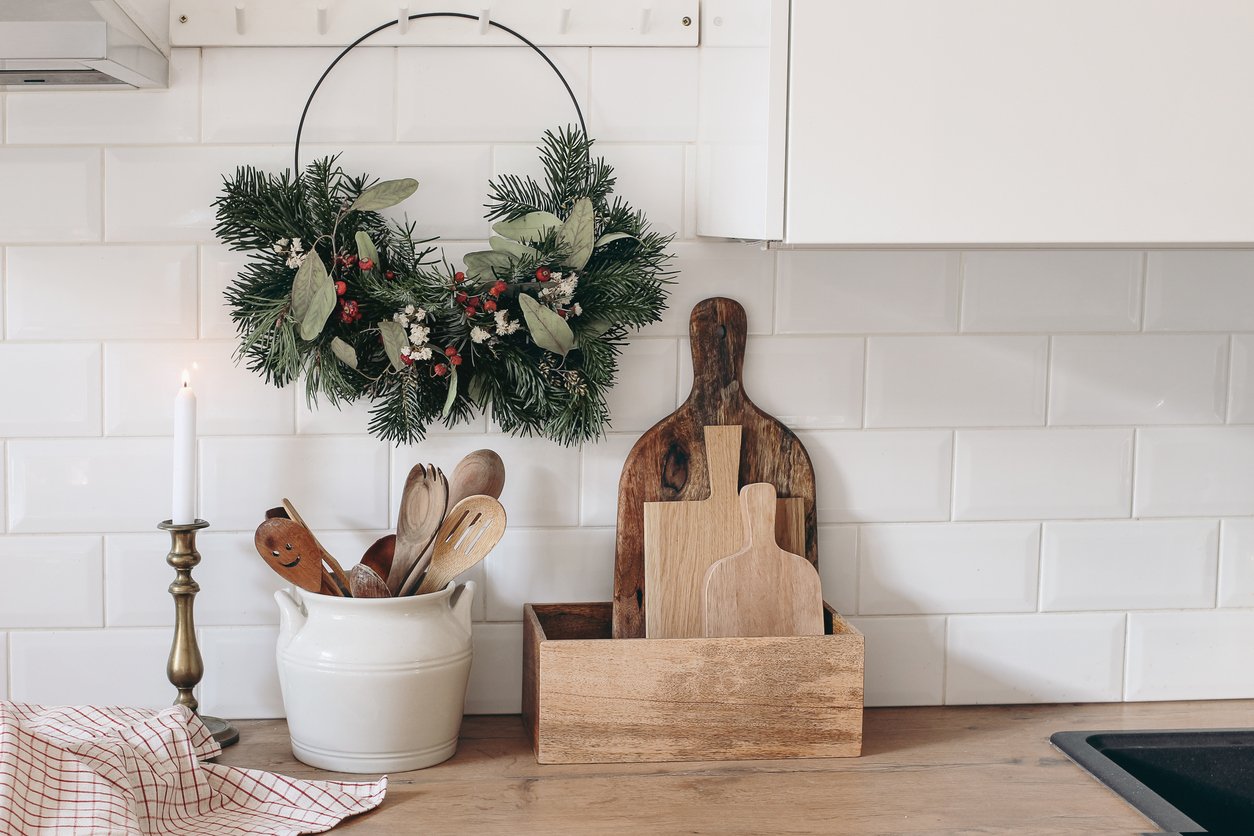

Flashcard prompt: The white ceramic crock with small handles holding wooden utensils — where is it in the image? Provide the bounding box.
[275,582,475,772]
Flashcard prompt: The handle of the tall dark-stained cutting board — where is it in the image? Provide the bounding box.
[688,296,749,405]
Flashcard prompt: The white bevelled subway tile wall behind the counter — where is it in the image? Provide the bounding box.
[0,48,1254,718]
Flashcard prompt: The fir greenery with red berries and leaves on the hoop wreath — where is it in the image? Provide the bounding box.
[214,128,672,445]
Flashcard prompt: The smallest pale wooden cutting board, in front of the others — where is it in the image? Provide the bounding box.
[702,483,823,637]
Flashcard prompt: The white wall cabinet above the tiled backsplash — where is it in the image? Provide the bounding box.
[697,0,1254,246]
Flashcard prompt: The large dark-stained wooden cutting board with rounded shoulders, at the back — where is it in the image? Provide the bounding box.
[613,297,819,638]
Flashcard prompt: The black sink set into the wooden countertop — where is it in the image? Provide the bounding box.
[1050,728,1254,833]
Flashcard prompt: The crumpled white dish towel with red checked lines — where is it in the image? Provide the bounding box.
[0,702,387,836]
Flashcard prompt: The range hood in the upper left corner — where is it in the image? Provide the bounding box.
[0,0,169,91]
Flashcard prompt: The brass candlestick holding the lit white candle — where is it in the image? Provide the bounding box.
[157,520,240,747]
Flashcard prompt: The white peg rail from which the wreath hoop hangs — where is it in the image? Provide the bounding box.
[169,0,700,46]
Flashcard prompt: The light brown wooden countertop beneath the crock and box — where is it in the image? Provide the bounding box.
[219,701,1254,836]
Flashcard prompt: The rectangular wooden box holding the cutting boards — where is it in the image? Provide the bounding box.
[523,602,864,763]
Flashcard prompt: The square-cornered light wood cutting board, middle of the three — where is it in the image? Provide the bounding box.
[645,426,805,638]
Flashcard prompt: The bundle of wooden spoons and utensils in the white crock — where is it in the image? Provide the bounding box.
[255,450,505,598]
